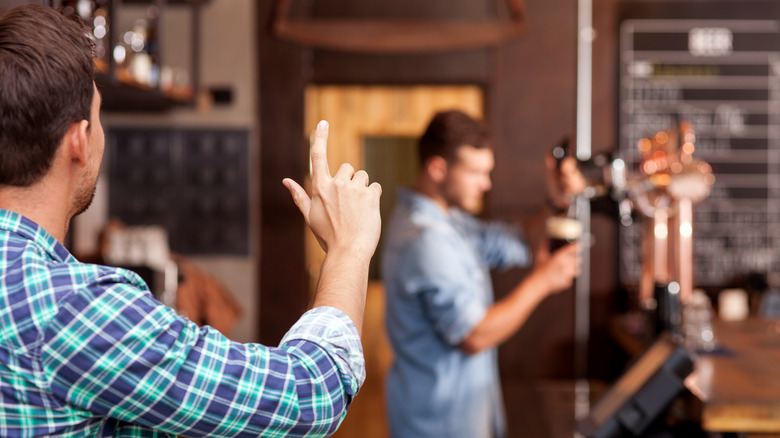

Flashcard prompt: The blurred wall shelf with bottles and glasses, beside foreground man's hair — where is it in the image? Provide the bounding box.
[53,0,201,111]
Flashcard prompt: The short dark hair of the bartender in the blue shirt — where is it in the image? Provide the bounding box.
[418,110,490,164]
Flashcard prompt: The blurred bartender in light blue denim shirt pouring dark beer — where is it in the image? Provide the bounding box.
[382,111,585,438]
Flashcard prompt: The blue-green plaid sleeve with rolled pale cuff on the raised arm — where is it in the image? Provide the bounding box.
[40,278,364,437]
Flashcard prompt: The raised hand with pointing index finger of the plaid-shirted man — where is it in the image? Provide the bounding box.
[283,120,382,258]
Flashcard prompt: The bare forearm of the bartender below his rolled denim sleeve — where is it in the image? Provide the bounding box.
[460,272,549,354]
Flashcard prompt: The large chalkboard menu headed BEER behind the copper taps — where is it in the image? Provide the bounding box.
[619,1,780,287]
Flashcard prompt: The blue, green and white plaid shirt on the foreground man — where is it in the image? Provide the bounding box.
[0,210,365,437]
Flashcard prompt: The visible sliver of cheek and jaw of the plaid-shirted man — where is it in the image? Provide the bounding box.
[71,85,106,217]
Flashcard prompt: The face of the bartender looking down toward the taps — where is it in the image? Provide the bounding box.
[442,145,495,213]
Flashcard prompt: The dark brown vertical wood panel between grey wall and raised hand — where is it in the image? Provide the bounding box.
[256,2,308,345]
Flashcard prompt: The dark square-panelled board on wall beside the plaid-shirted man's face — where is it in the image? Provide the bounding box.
[107,127,249,255]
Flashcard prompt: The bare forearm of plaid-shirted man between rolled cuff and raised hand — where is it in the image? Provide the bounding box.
[313,248,371,334]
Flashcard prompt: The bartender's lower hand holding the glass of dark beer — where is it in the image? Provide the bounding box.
[530,243,581,293]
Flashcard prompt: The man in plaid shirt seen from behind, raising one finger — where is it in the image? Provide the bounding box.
[0,6,381,437]
